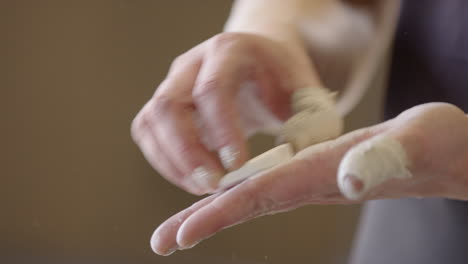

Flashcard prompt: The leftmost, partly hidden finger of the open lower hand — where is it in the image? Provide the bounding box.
[151,194,218,256]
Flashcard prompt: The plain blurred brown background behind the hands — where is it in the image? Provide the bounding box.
[0,0,381,264]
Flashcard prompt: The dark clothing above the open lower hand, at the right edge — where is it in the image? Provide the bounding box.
[386,0,468,118]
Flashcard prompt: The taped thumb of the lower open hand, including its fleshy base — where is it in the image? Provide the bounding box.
[338,103,466,199]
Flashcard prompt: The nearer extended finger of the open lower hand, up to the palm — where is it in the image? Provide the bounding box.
[177,158,322,248]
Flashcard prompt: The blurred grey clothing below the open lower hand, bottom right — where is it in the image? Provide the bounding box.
[352,199,468,264]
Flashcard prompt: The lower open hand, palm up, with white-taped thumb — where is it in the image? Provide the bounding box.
[151,103,468,255]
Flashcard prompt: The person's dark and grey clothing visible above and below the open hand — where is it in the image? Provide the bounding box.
[352,0,468,264]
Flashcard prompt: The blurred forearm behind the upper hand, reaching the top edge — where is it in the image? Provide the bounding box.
[225,0,384,114]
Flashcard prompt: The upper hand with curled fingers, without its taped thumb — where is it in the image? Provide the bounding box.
[132,33,318,194]
